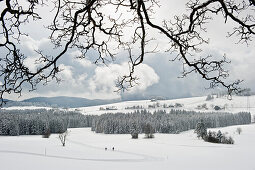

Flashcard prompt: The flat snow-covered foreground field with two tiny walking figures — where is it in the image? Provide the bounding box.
[0,124,255,170]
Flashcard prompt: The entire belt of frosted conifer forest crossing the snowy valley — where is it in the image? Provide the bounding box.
[0,109,251,136]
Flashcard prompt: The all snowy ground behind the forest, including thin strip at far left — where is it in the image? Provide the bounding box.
[4,95,255,119]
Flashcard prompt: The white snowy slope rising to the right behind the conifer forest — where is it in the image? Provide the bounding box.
[70,96,255,115]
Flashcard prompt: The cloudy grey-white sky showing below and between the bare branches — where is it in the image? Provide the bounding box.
[0,0,255,100]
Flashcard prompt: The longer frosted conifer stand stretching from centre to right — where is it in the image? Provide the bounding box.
[92,110,251,134]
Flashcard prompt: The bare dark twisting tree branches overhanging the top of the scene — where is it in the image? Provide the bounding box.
[0,0,255,103]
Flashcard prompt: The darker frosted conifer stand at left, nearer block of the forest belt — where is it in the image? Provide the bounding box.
[0,109,92,136]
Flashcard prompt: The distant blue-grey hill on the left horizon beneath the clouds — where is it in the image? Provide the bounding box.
[4,96,120,108]
